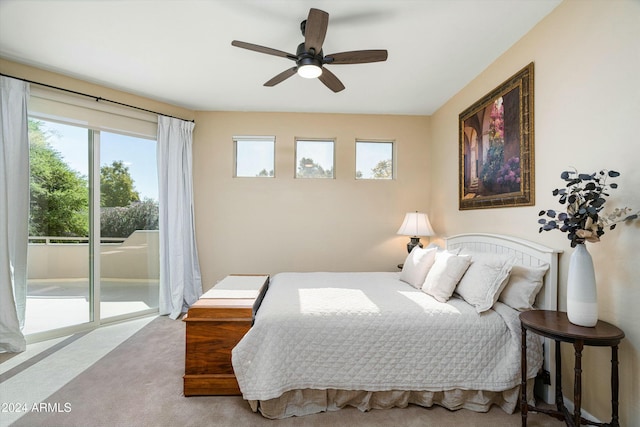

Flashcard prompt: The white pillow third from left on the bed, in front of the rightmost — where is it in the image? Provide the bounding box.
[455,252,516,313]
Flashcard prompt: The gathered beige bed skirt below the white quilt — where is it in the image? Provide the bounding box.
[249,379,535,419]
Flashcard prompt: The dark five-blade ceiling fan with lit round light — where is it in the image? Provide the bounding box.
[231,8,387,92]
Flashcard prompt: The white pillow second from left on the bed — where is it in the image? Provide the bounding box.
[422,250,471,302]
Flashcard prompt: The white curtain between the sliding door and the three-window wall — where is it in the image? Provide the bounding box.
[158,116,202,319]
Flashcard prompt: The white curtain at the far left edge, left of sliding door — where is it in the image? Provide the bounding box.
[0,76,29,353]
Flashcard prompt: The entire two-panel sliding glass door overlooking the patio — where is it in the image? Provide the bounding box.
[24,118,159,335]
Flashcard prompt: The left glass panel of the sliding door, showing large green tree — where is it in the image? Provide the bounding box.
[23,120,92,335]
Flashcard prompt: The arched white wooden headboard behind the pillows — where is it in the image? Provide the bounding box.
[444,233,562,403]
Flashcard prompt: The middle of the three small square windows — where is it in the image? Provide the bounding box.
[296,139,334,178]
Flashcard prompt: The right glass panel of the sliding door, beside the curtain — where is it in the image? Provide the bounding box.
[100,132,160,319]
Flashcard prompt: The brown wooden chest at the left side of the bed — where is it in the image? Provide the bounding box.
[183,275,269,396]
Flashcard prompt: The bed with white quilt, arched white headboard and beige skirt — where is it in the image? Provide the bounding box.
[232,234,558,419]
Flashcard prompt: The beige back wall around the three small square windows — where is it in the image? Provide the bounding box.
[193,111,429,290]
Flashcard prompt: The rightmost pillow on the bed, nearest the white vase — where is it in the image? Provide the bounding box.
[498,264,549,311]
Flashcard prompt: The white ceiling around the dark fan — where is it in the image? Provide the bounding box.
[0,0,561,115]
